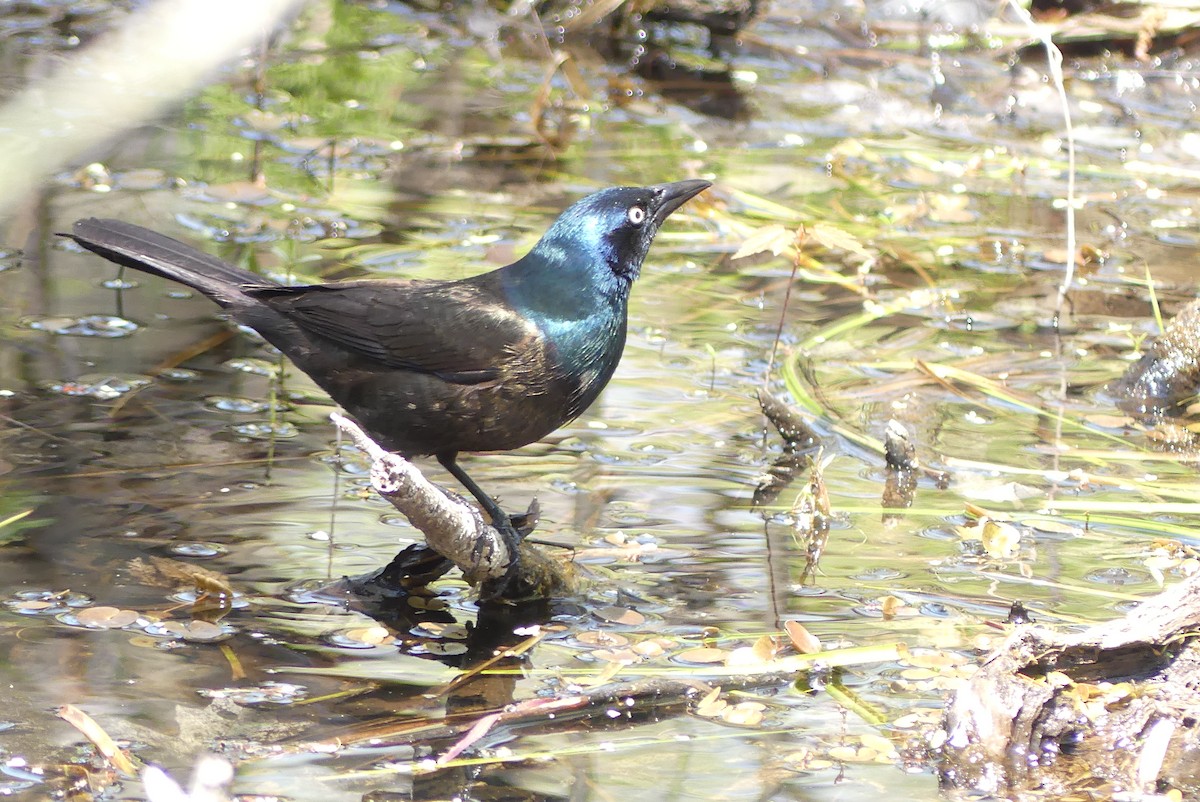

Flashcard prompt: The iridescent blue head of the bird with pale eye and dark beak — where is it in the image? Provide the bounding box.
[526,179,712,291]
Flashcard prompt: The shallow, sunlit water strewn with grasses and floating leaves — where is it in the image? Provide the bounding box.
[0,2,1196,802]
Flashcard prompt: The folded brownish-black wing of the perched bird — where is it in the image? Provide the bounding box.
[253,282,541,384]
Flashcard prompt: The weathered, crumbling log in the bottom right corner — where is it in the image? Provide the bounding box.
[936,576,1200,800]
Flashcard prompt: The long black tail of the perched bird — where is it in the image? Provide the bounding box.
[65,217,271,306]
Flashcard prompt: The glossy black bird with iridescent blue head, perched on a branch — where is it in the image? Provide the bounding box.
[67,180,710,583]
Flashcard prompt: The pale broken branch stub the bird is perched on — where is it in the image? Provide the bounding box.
[330,412,571,595]
